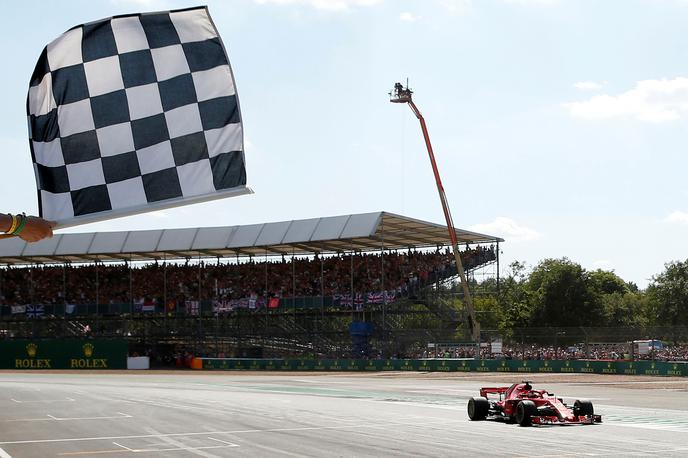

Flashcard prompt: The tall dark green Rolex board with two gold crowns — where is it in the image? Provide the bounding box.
[0,339,129,370]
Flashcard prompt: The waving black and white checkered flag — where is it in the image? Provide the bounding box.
[27,7,246,222]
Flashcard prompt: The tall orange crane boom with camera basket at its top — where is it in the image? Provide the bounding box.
[390,83,480,342]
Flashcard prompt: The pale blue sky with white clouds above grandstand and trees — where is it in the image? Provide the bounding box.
[0,0,688,287]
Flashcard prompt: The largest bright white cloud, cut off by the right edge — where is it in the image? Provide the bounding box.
[563,77,688,123]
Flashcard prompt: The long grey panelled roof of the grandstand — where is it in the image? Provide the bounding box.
[0,212,503,264]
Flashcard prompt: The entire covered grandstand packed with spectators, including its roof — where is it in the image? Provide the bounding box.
[0,212,503,362]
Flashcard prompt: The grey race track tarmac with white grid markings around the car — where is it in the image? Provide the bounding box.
[0,371,688,458]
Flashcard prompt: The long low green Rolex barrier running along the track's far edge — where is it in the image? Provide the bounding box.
[192,358,688,376]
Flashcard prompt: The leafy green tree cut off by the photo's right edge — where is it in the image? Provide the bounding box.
[647,259,688,326]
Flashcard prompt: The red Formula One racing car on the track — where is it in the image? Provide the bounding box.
[468,381,602,426]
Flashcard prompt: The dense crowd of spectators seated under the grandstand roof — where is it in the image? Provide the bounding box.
[0,246,496,305]
